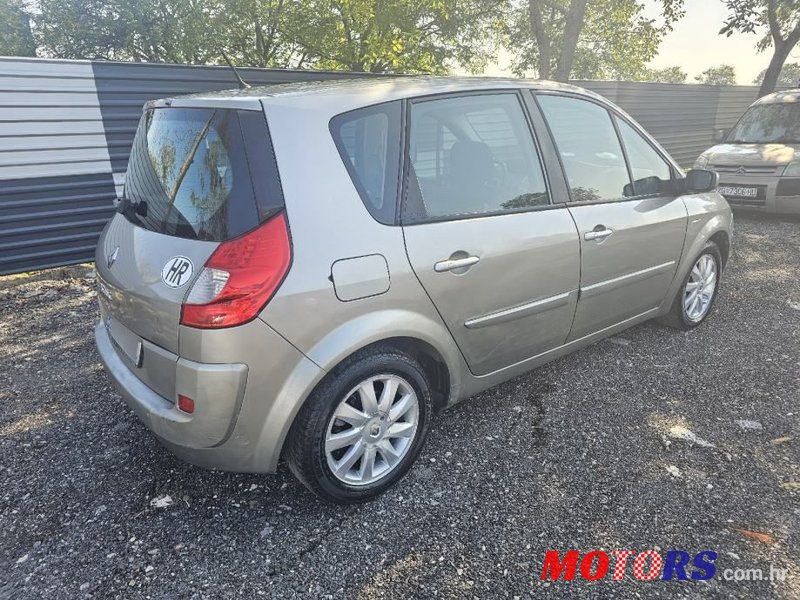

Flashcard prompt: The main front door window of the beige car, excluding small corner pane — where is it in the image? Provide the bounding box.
[537,95,630,202]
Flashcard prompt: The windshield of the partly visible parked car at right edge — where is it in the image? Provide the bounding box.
[726,103,800,144]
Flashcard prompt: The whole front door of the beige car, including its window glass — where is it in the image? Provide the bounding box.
[537,94,687,341]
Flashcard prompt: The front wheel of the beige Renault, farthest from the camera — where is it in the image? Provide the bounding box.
[662,242,722,331]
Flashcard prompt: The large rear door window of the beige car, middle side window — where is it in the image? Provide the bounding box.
[404,93,550,223]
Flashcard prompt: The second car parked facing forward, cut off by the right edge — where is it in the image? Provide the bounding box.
[694,90,800,214]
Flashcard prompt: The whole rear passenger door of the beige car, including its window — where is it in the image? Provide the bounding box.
[402,91,580,375]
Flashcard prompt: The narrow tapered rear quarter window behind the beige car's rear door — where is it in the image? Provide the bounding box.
[330,102,400,225]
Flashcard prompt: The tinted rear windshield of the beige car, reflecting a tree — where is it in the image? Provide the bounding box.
[120,108,283,241]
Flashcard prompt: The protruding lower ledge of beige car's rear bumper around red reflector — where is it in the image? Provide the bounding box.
[95,321,247,450]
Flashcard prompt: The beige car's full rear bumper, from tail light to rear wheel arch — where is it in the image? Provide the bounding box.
[95,319,325,473]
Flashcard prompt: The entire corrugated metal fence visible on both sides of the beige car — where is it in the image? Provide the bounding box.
[0,58,757,274]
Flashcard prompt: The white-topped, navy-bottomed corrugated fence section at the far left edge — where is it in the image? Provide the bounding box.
[0,58,114,274]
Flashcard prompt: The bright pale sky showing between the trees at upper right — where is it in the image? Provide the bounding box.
[485,0,800,85]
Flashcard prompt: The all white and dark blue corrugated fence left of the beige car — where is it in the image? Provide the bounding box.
[0,58,368,274]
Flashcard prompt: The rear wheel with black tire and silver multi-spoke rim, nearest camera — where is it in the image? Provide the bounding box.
[284,347,433,504]
